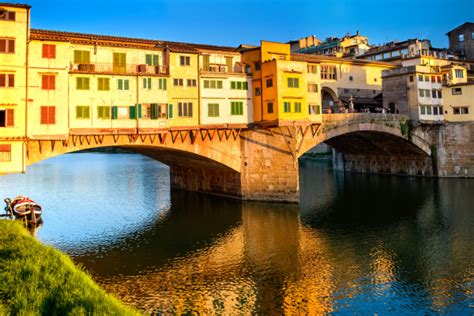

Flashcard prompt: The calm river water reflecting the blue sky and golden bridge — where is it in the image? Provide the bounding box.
[0,153,474,315]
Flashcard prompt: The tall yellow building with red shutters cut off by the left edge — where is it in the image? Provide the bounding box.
[0,3,31,174]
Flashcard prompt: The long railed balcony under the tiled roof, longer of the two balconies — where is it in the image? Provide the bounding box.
[69,63,169,76]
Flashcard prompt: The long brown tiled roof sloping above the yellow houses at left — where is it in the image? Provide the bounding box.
[30,29,238,53]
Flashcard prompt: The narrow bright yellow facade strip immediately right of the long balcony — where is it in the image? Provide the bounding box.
[168,52,200,126]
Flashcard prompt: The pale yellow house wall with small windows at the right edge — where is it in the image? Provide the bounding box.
[443,84,474,122]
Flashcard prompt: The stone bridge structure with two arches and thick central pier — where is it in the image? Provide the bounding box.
[27,114,432,202]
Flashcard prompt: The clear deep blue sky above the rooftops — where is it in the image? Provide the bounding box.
[15,0,474,47]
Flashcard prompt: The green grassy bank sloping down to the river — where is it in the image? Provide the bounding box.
[0,220,138,315]
